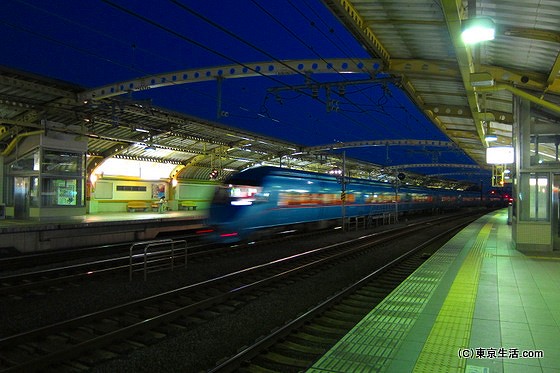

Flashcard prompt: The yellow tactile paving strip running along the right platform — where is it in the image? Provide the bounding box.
[414,223,493,372]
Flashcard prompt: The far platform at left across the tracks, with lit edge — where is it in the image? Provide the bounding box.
[0,210,206,254]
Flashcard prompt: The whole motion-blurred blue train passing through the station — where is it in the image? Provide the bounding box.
[207,166,508,243]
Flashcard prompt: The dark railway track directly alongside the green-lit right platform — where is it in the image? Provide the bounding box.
[208,222,460,373]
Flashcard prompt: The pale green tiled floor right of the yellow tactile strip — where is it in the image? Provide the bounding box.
[468,215,560,373]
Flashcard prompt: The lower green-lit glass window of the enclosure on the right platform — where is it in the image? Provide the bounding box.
[519,173,550,221]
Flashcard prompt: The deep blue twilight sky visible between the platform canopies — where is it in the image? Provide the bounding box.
[0,0,488,182]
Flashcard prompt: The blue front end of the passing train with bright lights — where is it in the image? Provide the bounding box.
[206,179,268,243]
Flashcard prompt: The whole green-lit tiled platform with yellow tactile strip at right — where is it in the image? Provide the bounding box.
[307,210,560,373]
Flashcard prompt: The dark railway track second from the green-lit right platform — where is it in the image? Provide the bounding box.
[0,211,476,371]
